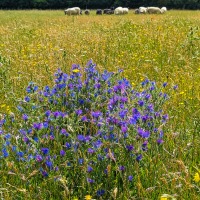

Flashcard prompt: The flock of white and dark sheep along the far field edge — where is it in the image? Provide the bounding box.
[64,7,167,15]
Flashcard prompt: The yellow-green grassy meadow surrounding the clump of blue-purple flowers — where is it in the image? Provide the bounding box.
[0,10,200,200]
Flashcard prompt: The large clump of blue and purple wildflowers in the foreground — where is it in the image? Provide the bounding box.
[0,61,171,199]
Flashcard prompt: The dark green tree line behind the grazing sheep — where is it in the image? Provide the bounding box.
[0,0,200,9]
